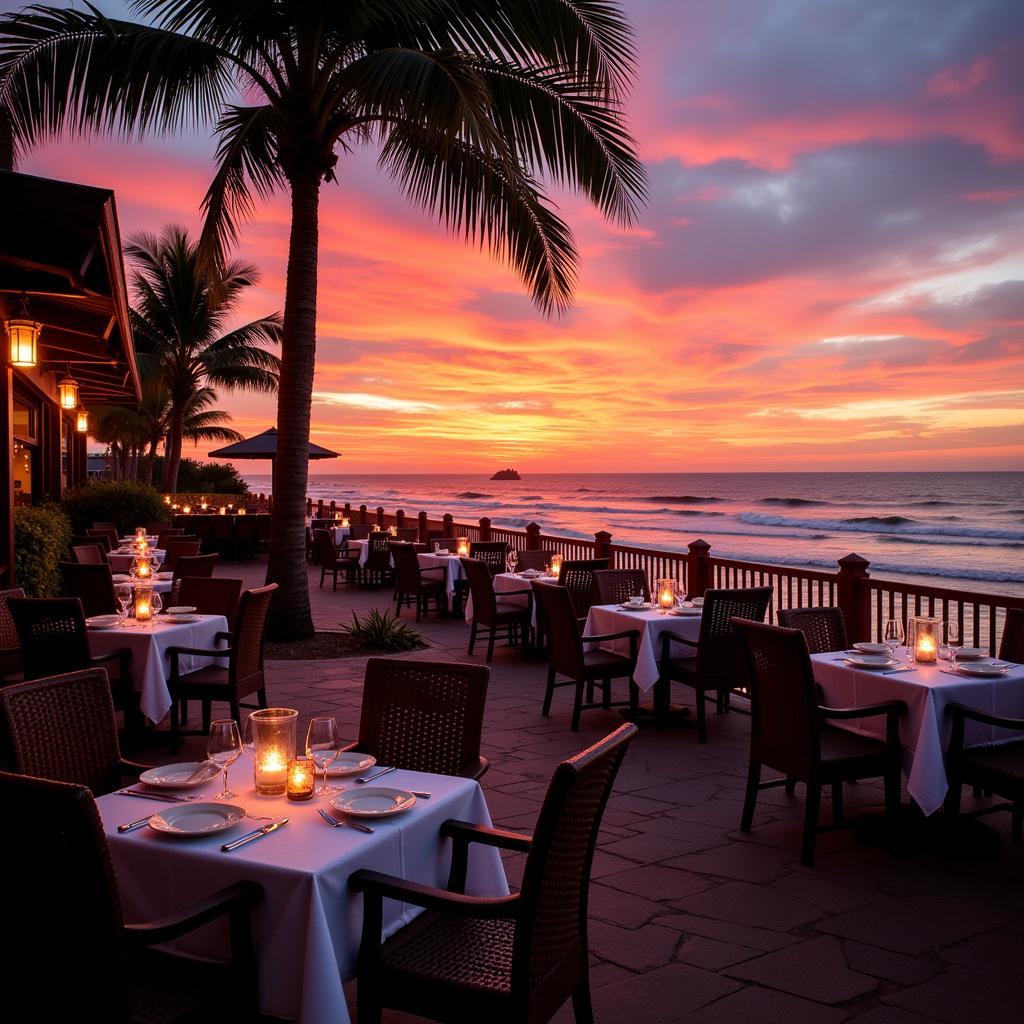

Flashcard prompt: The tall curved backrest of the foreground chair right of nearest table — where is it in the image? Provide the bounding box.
[512,724,637,1003]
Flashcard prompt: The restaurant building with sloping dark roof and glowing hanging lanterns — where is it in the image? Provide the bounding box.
[0,171,140,588]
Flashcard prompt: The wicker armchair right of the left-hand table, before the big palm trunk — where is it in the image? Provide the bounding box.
[167,583,278,748]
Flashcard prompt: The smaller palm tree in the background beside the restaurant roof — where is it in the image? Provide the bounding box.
[125,224,281,494]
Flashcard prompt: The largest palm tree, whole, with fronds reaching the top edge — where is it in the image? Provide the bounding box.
[0,0,644,637]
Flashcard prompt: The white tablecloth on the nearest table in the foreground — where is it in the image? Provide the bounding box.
[97,770,508,1024]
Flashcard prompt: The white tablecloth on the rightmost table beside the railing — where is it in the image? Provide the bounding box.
[811,650,1024,814]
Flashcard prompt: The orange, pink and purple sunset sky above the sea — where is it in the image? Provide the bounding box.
[9,0,1024,472]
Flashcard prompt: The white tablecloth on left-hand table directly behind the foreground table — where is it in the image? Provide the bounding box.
[89,615,227,723]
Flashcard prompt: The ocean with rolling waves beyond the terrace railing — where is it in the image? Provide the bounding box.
[246,466,1024,596]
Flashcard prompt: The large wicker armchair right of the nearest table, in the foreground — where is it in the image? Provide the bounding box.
[349,725,637,1024]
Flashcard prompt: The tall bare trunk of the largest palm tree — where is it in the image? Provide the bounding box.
[266,171,321,640]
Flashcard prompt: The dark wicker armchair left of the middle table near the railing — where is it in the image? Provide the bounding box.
[531,580,640,732]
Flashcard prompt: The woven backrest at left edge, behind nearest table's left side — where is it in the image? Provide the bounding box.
[0,669,121,796]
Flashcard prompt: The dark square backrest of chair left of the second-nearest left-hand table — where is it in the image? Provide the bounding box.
[8,597,90,679]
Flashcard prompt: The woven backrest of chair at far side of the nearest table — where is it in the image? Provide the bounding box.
[358,657,490,775]
